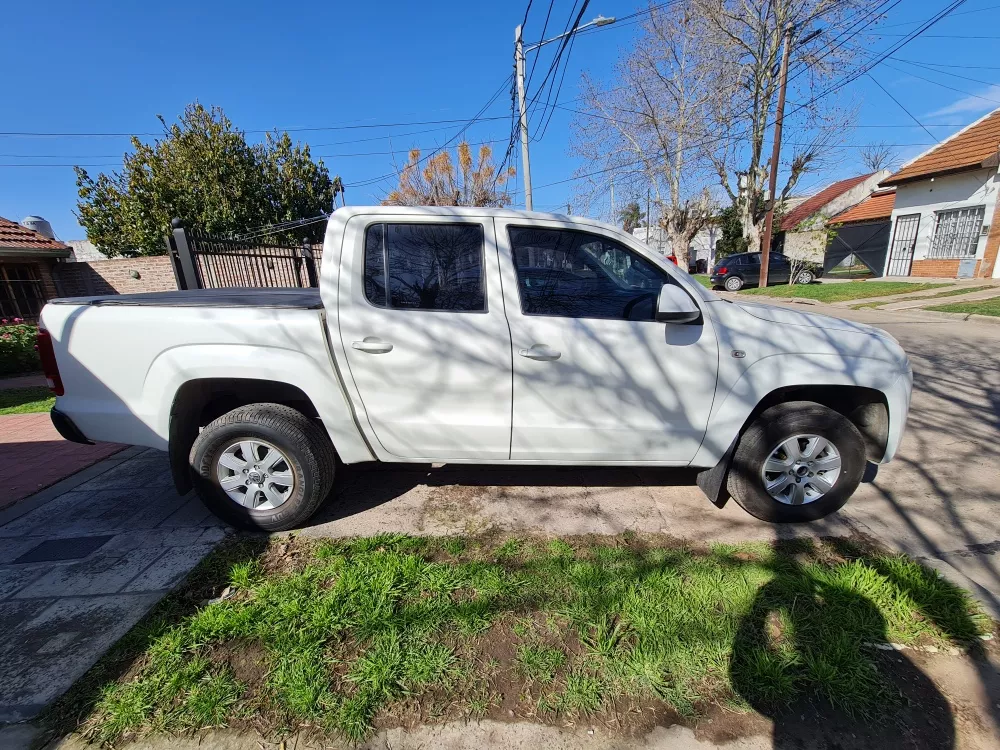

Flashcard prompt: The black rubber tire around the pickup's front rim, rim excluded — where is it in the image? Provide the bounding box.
[727,401,865,523]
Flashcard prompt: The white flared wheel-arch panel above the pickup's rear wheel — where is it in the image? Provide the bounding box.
[142,344,373,463]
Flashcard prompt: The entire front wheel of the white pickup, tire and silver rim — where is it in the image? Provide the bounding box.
[728,401,865,523]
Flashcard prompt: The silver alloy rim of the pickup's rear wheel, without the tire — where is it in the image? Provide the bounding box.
[216,439,295,510]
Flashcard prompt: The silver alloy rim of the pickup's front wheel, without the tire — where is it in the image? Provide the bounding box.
[760,434,843,505]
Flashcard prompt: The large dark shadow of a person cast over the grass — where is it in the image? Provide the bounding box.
[730,540,956,750]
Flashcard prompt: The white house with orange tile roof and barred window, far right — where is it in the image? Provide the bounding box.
[881,109,1000,278]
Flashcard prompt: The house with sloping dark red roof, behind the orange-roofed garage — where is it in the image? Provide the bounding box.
[774,170,889,263]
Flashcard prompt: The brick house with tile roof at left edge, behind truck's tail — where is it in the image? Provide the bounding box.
[0,217,70,320]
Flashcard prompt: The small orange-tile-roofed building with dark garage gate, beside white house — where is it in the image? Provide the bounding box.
[823,188,896,276]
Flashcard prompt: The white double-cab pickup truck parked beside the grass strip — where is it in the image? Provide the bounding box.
[39,207,912,530]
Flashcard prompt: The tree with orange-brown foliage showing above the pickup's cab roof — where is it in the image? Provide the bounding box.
[382,141,515,208]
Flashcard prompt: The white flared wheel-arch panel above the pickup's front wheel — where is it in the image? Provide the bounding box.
[691,354,913,467]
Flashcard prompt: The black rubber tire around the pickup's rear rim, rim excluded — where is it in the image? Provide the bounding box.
[190,404,337,531]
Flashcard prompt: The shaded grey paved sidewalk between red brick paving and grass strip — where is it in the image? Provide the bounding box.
[0,448,225,723]
